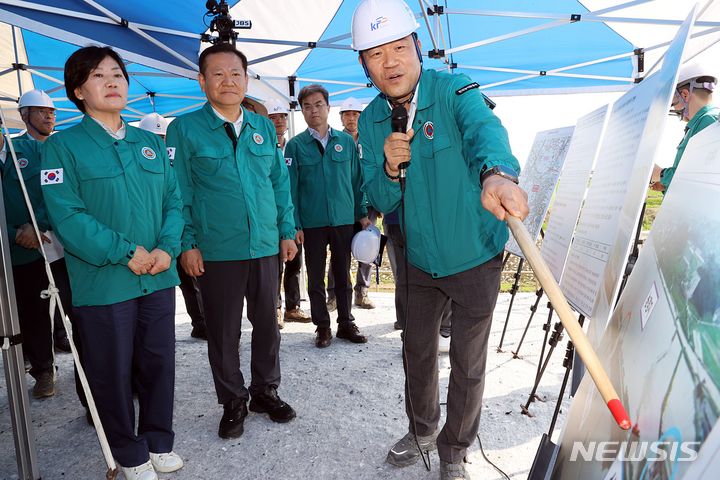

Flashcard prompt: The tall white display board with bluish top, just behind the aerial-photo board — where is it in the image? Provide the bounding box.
[561,9,694,336]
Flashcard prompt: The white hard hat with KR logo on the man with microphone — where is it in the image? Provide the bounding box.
[352,0,420,51]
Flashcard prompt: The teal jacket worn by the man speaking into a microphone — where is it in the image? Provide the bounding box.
[359,70,520,278]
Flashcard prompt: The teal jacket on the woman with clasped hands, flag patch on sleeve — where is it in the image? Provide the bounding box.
[40,115,183,306]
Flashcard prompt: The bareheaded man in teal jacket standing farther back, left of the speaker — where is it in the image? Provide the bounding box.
[285,84,370,348]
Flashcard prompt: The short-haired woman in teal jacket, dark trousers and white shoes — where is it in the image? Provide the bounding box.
[40,46,183,480]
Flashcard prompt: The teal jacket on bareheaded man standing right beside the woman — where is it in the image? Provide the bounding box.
[167,103,295,261]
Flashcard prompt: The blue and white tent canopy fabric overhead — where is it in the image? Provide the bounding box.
[0,0,720,129]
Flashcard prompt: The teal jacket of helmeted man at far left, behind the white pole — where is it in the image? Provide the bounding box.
[0,137,50,265]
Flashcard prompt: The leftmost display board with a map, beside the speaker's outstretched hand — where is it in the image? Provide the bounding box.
[505,127,574,258]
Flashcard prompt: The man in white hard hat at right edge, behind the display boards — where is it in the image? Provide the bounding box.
[650,63,720,192]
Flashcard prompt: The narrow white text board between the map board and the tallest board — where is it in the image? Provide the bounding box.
[540,105,610,282]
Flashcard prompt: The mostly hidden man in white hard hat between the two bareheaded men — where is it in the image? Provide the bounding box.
[265,99,310,329]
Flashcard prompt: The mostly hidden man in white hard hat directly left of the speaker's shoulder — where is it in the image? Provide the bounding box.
[327,97,378,310]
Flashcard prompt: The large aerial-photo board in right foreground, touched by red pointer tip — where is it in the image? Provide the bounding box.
[552,119,720,480]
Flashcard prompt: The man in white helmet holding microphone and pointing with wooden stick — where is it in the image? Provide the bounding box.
[352,0,528,480]
